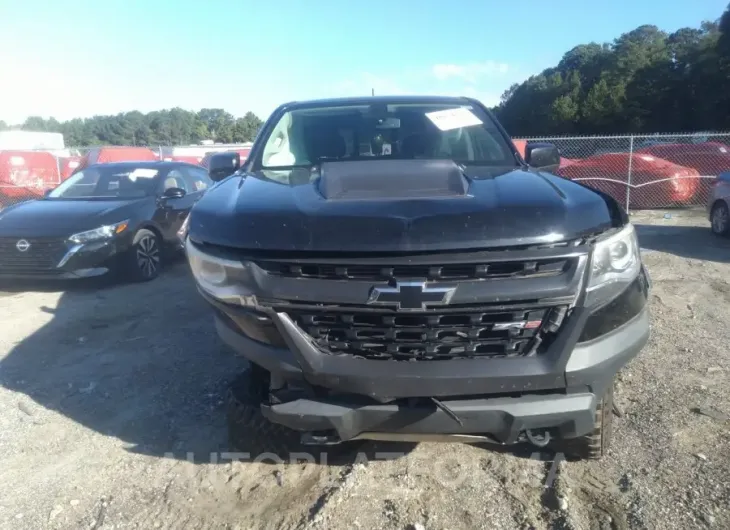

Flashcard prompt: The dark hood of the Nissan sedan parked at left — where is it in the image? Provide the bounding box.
[0,198,150,237]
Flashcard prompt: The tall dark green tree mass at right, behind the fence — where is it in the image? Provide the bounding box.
[495,5,730,136]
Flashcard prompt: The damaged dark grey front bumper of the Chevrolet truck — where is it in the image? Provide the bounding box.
[202,270,649,444]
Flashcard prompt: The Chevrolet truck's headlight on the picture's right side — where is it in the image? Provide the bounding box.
[587,224,641,305]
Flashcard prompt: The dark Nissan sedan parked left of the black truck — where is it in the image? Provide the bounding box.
[0,162,212,281]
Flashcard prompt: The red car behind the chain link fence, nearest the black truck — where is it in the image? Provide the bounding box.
[556,153,699,208]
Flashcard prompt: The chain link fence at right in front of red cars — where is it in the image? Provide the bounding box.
[521,133,730,210]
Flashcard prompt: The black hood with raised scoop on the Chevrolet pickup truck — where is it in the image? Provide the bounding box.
[189,161,612,252]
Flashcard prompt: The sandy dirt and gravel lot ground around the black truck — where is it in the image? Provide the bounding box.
[0,213,730,530]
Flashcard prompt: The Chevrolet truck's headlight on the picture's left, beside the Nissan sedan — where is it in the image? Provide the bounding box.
[185,238,256,306]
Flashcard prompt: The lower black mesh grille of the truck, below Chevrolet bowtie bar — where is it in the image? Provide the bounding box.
[287,307,567,361]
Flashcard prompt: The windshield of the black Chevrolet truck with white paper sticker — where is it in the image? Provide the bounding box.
[260,102,517,169]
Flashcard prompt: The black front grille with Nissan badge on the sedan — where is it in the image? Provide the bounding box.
[0,237,67,275]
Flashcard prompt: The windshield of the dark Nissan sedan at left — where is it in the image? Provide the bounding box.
[47,166,159,199]
